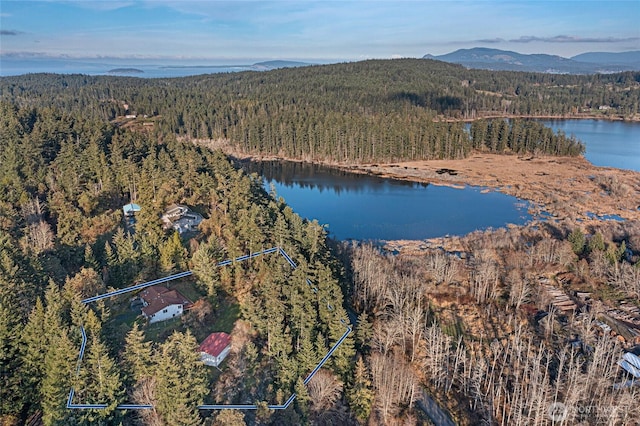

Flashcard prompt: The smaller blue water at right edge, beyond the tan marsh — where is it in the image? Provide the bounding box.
[542,120,640,171]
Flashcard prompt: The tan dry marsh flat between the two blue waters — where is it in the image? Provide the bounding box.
[191,130,640,252]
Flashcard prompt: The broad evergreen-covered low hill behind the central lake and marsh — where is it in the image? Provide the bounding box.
[0,59,640,162]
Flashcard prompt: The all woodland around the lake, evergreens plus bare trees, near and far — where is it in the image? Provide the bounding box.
[0,59,640,426]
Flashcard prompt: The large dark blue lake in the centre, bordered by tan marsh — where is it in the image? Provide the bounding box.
[244,161,531,240]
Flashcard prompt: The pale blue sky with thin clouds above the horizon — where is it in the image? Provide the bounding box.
[0,0,640,63]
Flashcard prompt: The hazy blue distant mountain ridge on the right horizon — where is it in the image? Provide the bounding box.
[423,47,640,74]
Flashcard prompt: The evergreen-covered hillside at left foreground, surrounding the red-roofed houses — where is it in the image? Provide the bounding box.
[0,103,353,425]
